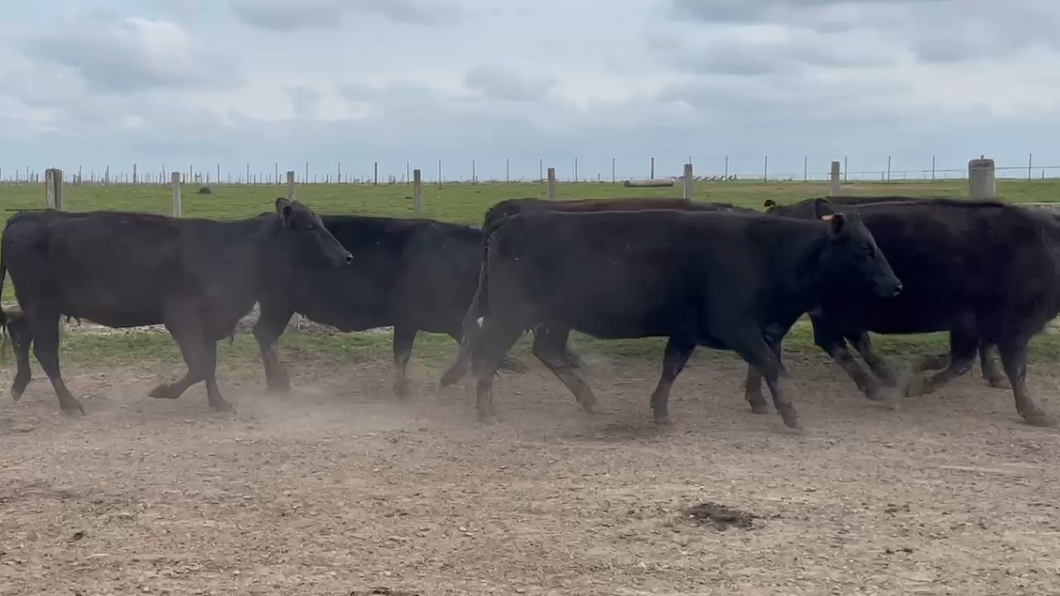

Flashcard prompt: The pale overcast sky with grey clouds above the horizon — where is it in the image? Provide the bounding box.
[0,0,1060,178]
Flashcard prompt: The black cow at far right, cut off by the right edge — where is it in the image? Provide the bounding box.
[747,199,1060,425]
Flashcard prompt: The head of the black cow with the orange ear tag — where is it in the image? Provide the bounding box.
[813,198,902,298]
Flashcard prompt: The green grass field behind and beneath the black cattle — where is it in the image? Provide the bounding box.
[0,180,1060,363]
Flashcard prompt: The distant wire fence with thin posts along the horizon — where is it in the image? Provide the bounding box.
[0,156,1060,186]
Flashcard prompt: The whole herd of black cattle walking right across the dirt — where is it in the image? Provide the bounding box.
[0,196,1060,427]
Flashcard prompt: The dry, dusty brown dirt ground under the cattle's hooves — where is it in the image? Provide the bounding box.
[0,347,1060,596]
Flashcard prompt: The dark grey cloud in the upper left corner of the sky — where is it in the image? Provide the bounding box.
[24,12,237,93]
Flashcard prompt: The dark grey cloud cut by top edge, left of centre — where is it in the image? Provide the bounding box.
[229,0,461,31]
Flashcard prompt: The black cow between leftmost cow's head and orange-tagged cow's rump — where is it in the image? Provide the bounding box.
[253,215,520,396]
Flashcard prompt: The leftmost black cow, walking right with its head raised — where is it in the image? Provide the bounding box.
[0,198,353,413]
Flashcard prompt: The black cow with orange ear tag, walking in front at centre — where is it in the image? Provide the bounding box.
[464,202,901,427]
